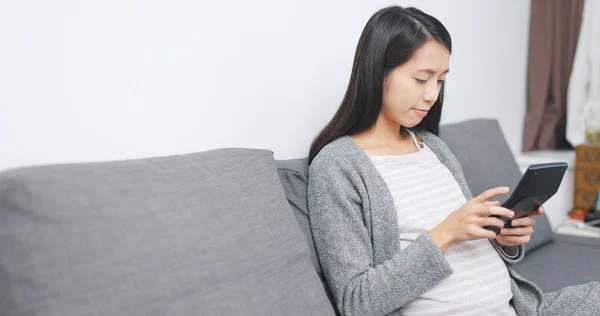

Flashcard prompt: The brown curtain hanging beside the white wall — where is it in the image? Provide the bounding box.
[522,0,584,151]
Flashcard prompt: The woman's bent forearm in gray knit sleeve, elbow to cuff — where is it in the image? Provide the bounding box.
[320,234,452,315]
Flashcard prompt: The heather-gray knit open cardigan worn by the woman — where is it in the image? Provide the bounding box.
[308,130,582,316]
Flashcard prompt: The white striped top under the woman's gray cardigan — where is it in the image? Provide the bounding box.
[368,130,516,316]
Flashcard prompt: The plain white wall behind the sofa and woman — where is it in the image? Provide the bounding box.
[0,0,529,173]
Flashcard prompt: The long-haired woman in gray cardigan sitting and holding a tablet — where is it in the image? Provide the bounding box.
[308,6,600,315]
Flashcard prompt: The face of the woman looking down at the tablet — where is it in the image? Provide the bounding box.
[381,40,450,128]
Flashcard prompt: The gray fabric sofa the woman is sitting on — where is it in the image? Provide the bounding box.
[0,120,600,316]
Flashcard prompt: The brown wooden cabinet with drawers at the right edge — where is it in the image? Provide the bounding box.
[573,145,600,210]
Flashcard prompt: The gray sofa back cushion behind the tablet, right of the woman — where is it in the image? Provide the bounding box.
[440,119,554,252]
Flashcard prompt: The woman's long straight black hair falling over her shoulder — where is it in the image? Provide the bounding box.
[308,6,452,164]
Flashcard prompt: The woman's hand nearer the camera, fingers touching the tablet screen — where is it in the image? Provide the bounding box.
[429,187,514,252]
